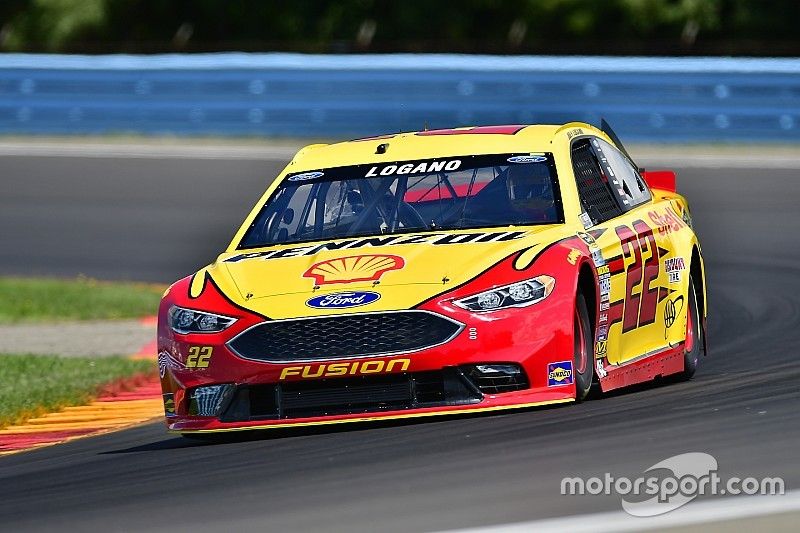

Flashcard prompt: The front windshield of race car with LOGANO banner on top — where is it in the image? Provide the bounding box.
[239,153,563,249]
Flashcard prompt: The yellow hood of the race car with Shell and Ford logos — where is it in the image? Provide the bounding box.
[206,225,561,318]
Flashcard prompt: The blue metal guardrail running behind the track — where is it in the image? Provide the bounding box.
[0,53,800,142]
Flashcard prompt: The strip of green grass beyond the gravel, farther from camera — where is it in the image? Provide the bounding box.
[0,278,164,324]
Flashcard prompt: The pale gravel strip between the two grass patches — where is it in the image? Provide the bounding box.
[0,320,156,357]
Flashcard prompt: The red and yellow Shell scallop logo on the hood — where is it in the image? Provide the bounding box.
[303,254,406,285]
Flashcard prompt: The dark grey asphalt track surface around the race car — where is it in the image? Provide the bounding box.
[0,150,800,531]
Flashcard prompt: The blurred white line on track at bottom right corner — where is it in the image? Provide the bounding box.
[444,491,800,533]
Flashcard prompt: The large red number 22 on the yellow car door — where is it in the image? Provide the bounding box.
[616,220,660,333]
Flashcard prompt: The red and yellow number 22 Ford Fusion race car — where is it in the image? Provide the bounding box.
[158,121,707,437]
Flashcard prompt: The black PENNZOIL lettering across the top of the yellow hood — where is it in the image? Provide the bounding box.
[225,231,528,263]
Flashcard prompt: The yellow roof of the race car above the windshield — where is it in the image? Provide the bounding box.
[286,122,602,173]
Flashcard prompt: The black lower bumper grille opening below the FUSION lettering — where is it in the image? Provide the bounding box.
[221,368,482,422]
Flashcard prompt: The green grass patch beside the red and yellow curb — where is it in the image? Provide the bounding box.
[0,355,155,428]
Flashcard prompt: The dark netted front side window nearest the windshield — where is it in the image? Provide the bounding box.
[571,138,622,224]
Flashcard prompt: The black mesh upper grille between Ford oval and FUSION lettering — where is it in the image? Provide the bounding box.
[228,311,464,363]
